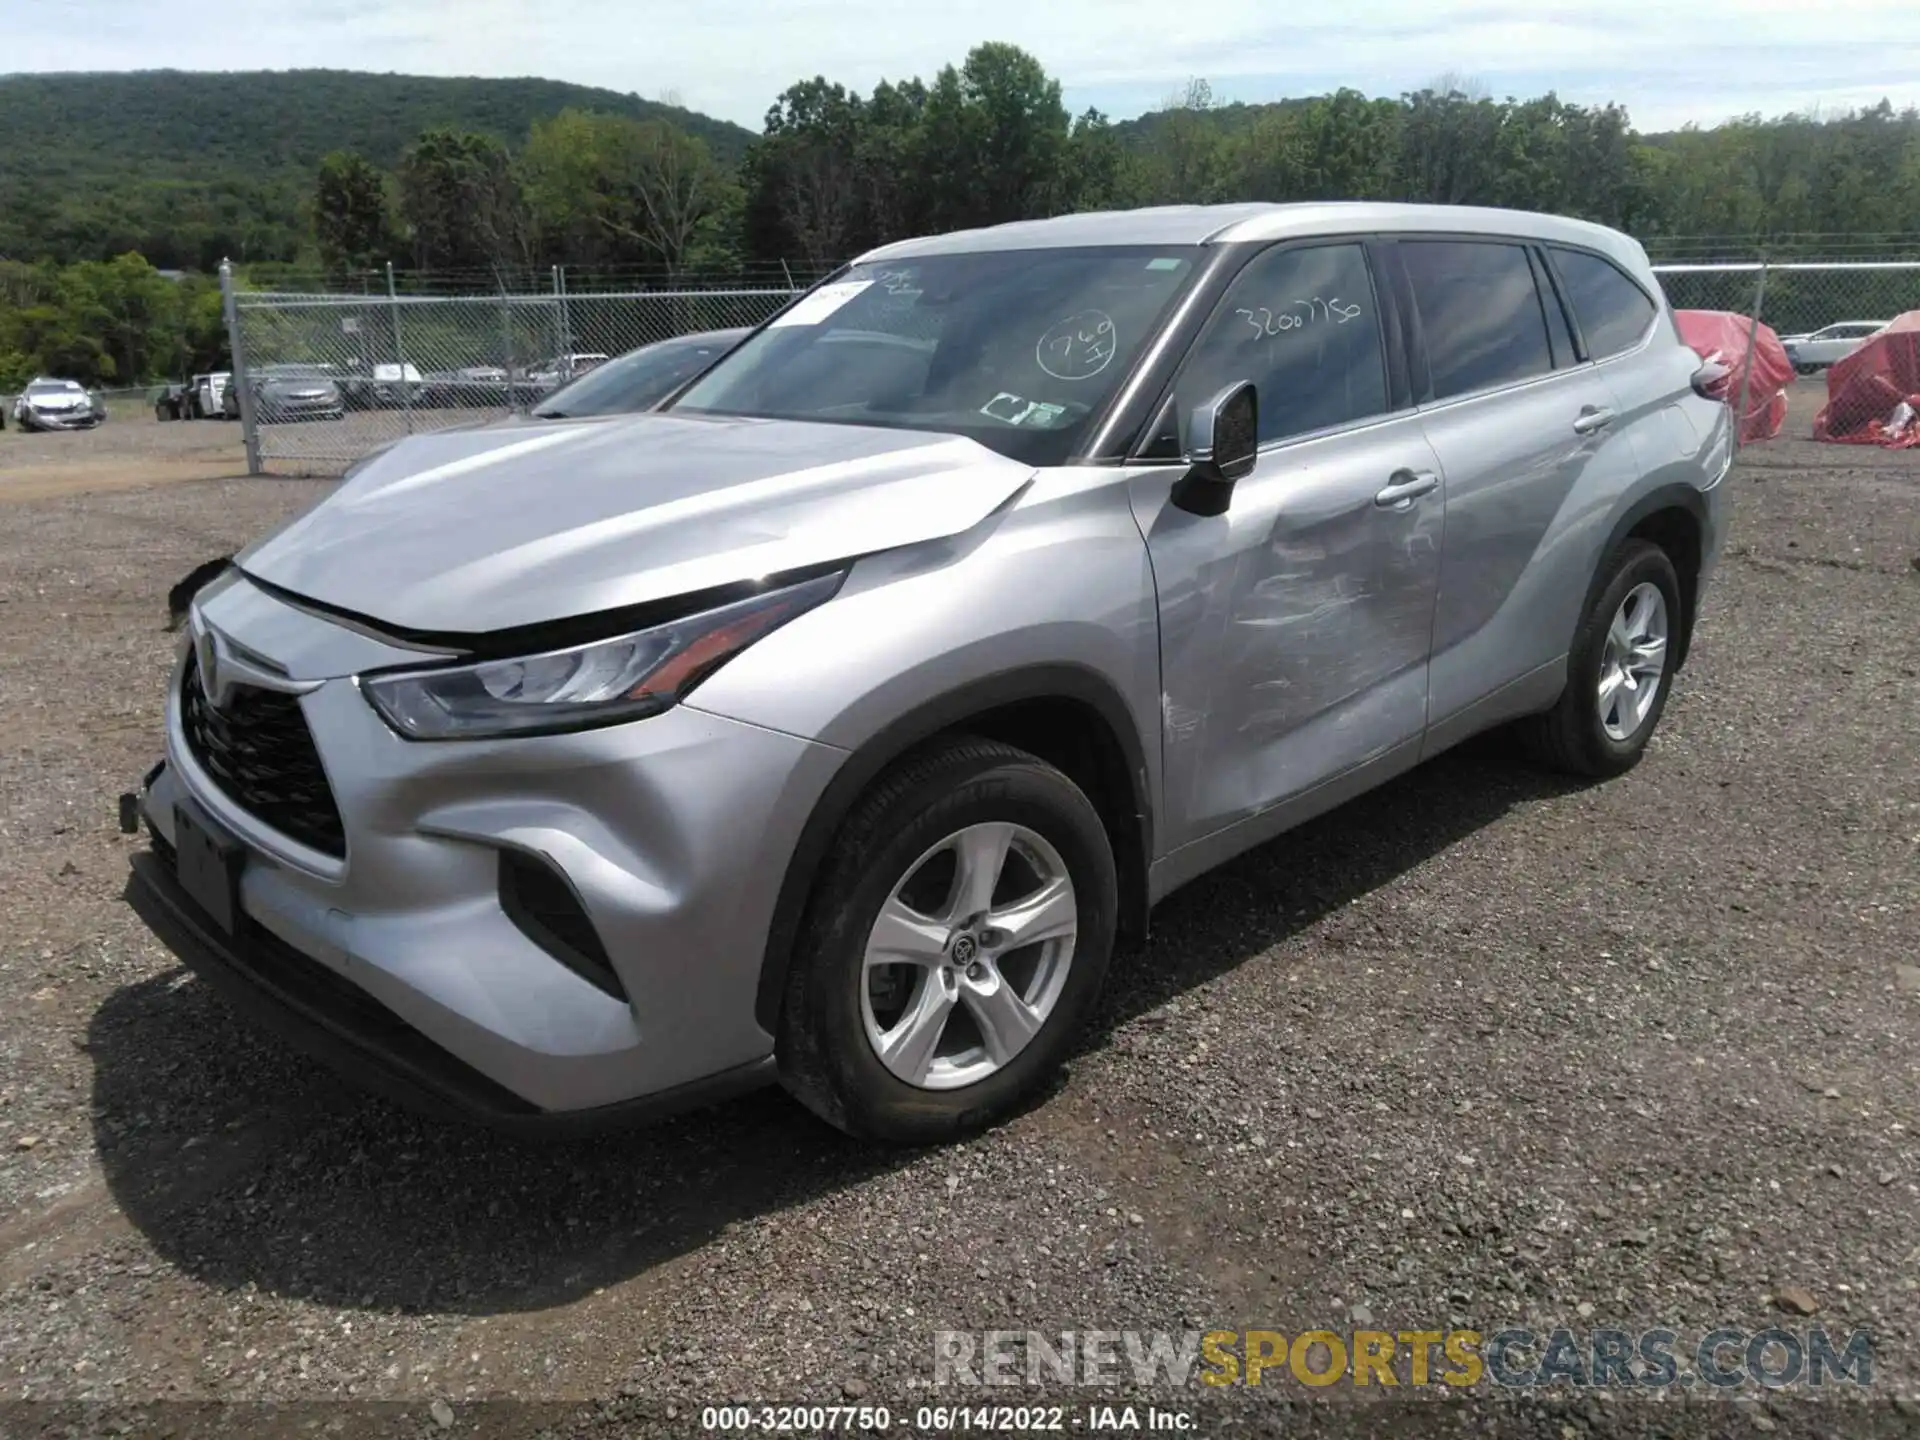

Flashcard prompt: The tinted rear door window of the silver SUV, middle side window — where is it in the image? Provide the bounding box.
[1400,240,1553,399]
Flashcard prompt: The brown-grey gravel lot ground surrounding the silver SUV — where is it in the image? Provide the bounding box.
[0,378,1920,1436]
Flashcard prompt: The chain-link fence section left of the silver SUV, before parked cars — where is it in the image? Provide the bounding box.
[221,267,799,474]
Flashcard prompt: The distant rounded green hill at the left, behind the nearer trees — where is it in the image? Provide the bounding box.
[0,69,753,269]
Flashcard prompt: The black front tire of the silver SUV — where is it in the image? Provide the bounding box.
[776,737,1119,1144]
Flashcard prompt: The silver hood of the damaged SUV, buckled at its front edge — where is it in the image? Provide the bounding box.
[234,415,1033,634]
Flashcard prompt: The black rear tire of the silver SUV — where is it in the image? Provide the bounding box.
[1521,540,1686,780]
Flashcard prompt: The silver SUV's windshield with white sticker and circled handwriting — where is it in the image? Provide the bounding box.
[670,246,1200,465]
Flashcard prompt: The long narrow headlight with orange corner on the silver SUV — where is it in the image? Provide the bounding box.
[359,572,845,739]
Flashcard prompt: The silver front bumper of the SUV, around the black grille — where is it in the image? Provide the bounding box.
[129,580,843,1129]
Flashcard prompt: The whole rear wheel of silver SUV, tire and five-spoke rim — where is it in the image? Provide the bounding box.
[1521,540,1682,780]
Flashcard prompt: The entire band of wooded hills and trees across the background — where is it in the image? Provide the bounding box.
[0,44,1920,388]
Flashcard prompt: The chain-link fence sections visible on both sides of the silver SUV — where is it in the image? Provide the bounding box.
[221,252,1920,474]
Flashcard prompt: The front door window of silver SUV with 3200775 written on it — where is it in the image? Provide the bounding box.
[1175,244,1388,444]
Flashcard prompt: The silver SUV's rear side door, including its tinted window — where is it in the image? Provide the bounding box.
[1392,234,1636,751]
